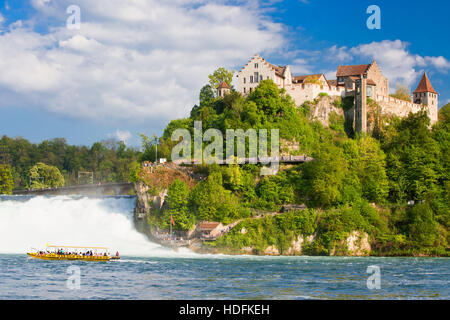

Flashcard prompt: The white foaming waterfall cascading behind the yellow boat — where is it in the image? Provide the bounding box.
[0,196,195,257]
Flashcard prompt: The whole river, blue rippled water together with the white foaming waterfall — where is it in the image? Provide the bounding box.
[0,197,450,299]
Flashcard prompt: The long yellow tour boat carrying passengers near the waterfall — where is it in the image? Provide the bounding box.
[27,244,120,261]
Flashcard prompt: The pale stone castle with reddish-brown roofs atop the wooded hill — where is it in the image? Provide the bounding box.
[237,54,438,132]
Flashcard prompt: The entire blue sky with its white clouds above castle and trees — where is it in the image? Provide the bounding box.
[0,0,450,146]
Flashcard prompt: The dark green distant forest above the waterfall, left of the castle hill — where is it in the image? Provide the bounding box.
[0,136,140,189]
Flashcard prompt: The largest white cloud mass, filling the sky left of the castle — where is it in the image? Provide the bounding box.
[0,0,285,123]
